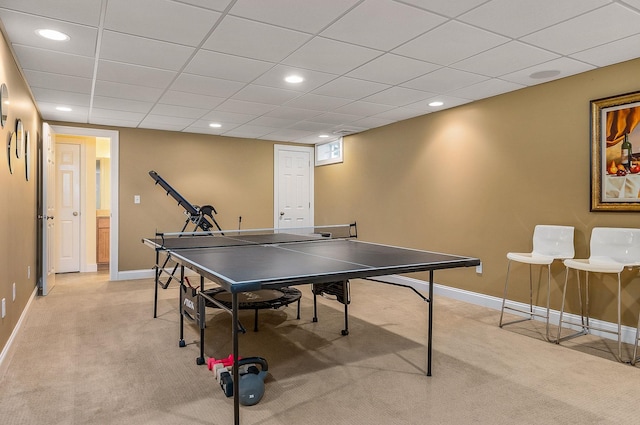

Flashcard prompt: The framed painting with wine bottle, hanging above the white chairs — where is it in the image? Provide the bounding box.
[591,92,640,211]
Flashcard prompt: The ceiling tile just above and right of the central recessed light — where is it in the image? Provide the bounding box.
[283,37,382,74]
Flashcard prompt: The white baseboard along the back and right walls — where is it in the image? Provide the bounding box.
[118,270,636,344]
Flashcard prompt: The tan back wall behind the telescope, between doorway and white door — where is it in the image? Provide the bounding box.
[118,129,274,270]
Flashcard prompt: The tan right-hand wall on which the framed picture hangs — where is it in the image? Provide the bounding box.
[315,59,640,327]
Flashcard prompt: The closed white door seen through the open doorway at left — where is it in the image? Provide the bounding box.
[56,143,80,273]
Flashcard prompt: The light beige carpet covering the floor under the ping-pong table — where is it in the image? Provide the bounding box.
[0,273,640,425]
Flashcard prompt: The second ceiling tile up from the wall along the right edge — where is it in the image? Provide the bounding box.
[522,4,640,55]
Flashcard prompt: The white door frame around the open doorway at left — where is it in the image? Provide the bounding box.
[51,125,120,280]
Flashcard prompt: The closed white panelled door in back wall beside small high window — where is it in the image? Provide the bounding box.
[274,145,313,228]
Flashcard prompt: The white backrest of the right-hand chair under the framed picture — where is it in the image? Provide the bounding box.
[589,227,640,265]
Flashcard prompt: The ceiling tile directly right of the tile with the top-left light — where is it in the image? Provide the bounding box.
[100,31,194,71]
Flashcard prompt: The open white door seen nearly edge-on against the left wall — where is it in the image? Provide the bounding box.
[38,123,56,295]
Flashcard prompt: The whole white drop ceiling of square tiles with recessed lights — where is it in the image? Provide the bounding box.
[0,0,640,144]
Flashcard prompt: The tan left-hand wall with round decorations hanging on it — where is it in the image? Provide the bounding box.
[0,29,42,350]
